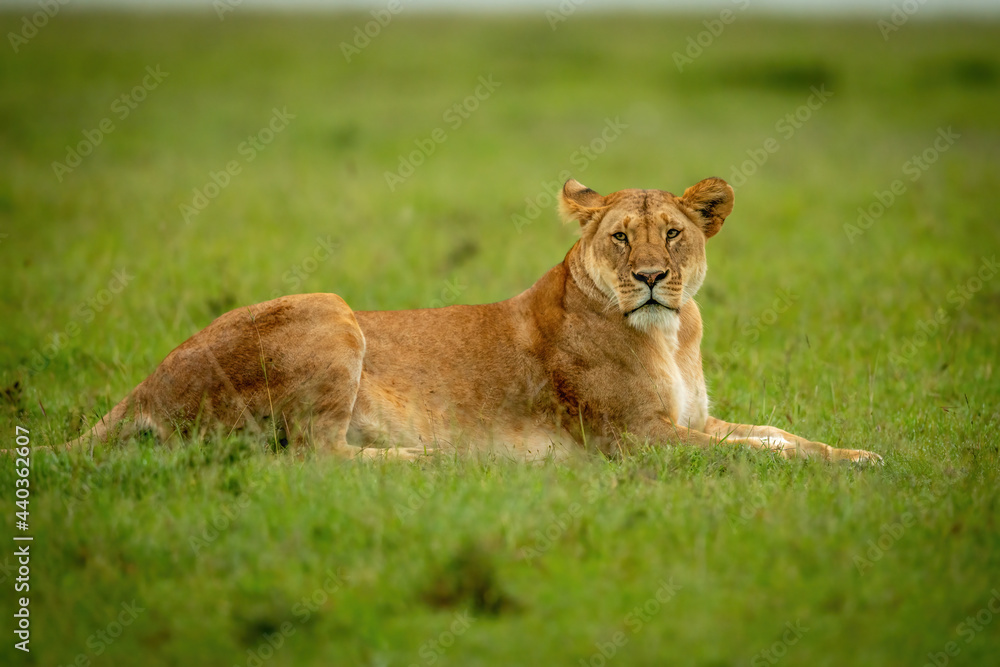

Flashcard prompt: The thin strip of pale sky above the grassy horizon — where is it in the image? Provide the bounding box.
[0,0,1000,19]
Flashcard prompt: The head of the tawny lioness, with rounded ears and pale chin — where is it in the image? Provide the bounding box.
[560,178,733,330]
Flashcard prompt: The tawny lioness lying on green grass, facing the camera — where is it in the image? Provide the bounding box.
[66,178,881,461]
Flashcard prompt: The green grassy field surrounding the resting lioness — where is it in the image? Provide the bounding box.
[0,10,1000,667]
